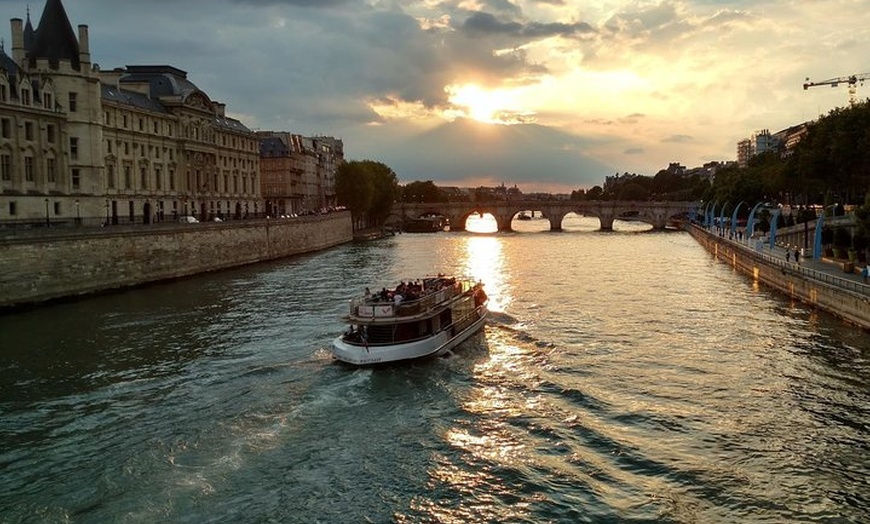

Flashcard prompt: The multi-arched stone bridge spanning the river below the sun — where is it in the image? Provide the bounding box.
[391,200,699,231]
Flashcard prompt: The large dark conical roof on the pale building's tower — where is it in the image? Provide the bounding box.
[28,0,81,70]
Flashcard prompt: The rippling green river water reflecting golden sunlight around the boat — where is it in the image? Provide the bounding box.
[0,217,870,524]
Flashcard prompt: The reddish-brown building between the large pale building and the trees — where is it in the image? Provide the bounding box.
[258,131,344,216]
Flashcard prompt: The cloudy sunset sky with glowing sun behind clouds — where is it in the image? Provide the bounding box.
[6,0,870,192]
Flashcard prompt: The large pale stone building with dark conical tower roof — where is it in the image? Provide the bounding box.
[0,0,262,224]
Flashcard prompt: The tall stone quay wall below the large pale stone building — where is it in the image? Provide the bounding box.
[0,212,353,309]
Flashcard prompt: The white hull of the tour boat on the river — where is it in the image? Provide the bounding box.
[332,306,487,366]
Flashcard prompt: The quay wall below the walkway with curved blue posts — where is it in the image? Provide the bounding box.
[689,226,870,329]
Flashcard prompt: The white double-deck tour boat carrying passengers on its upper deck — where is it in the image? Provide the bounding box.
[332,275,488,366]
